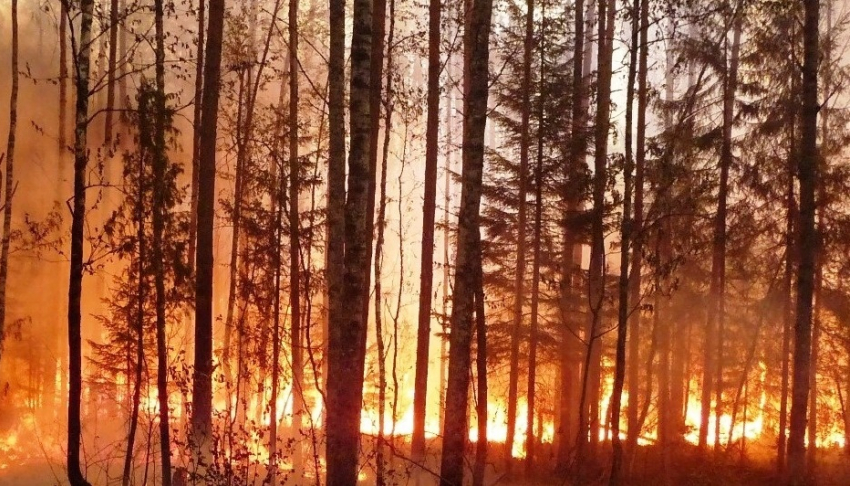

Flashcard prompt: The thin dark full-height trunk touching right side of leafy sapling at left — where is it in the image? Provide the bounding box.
[151,0,171,486]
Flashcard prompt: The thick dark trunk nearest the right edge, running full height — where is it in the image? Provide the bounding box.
[788,0,820,484]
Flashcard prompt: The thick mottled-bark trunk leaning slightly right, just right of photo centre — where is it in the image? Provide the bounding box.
[440,0,493,478]
